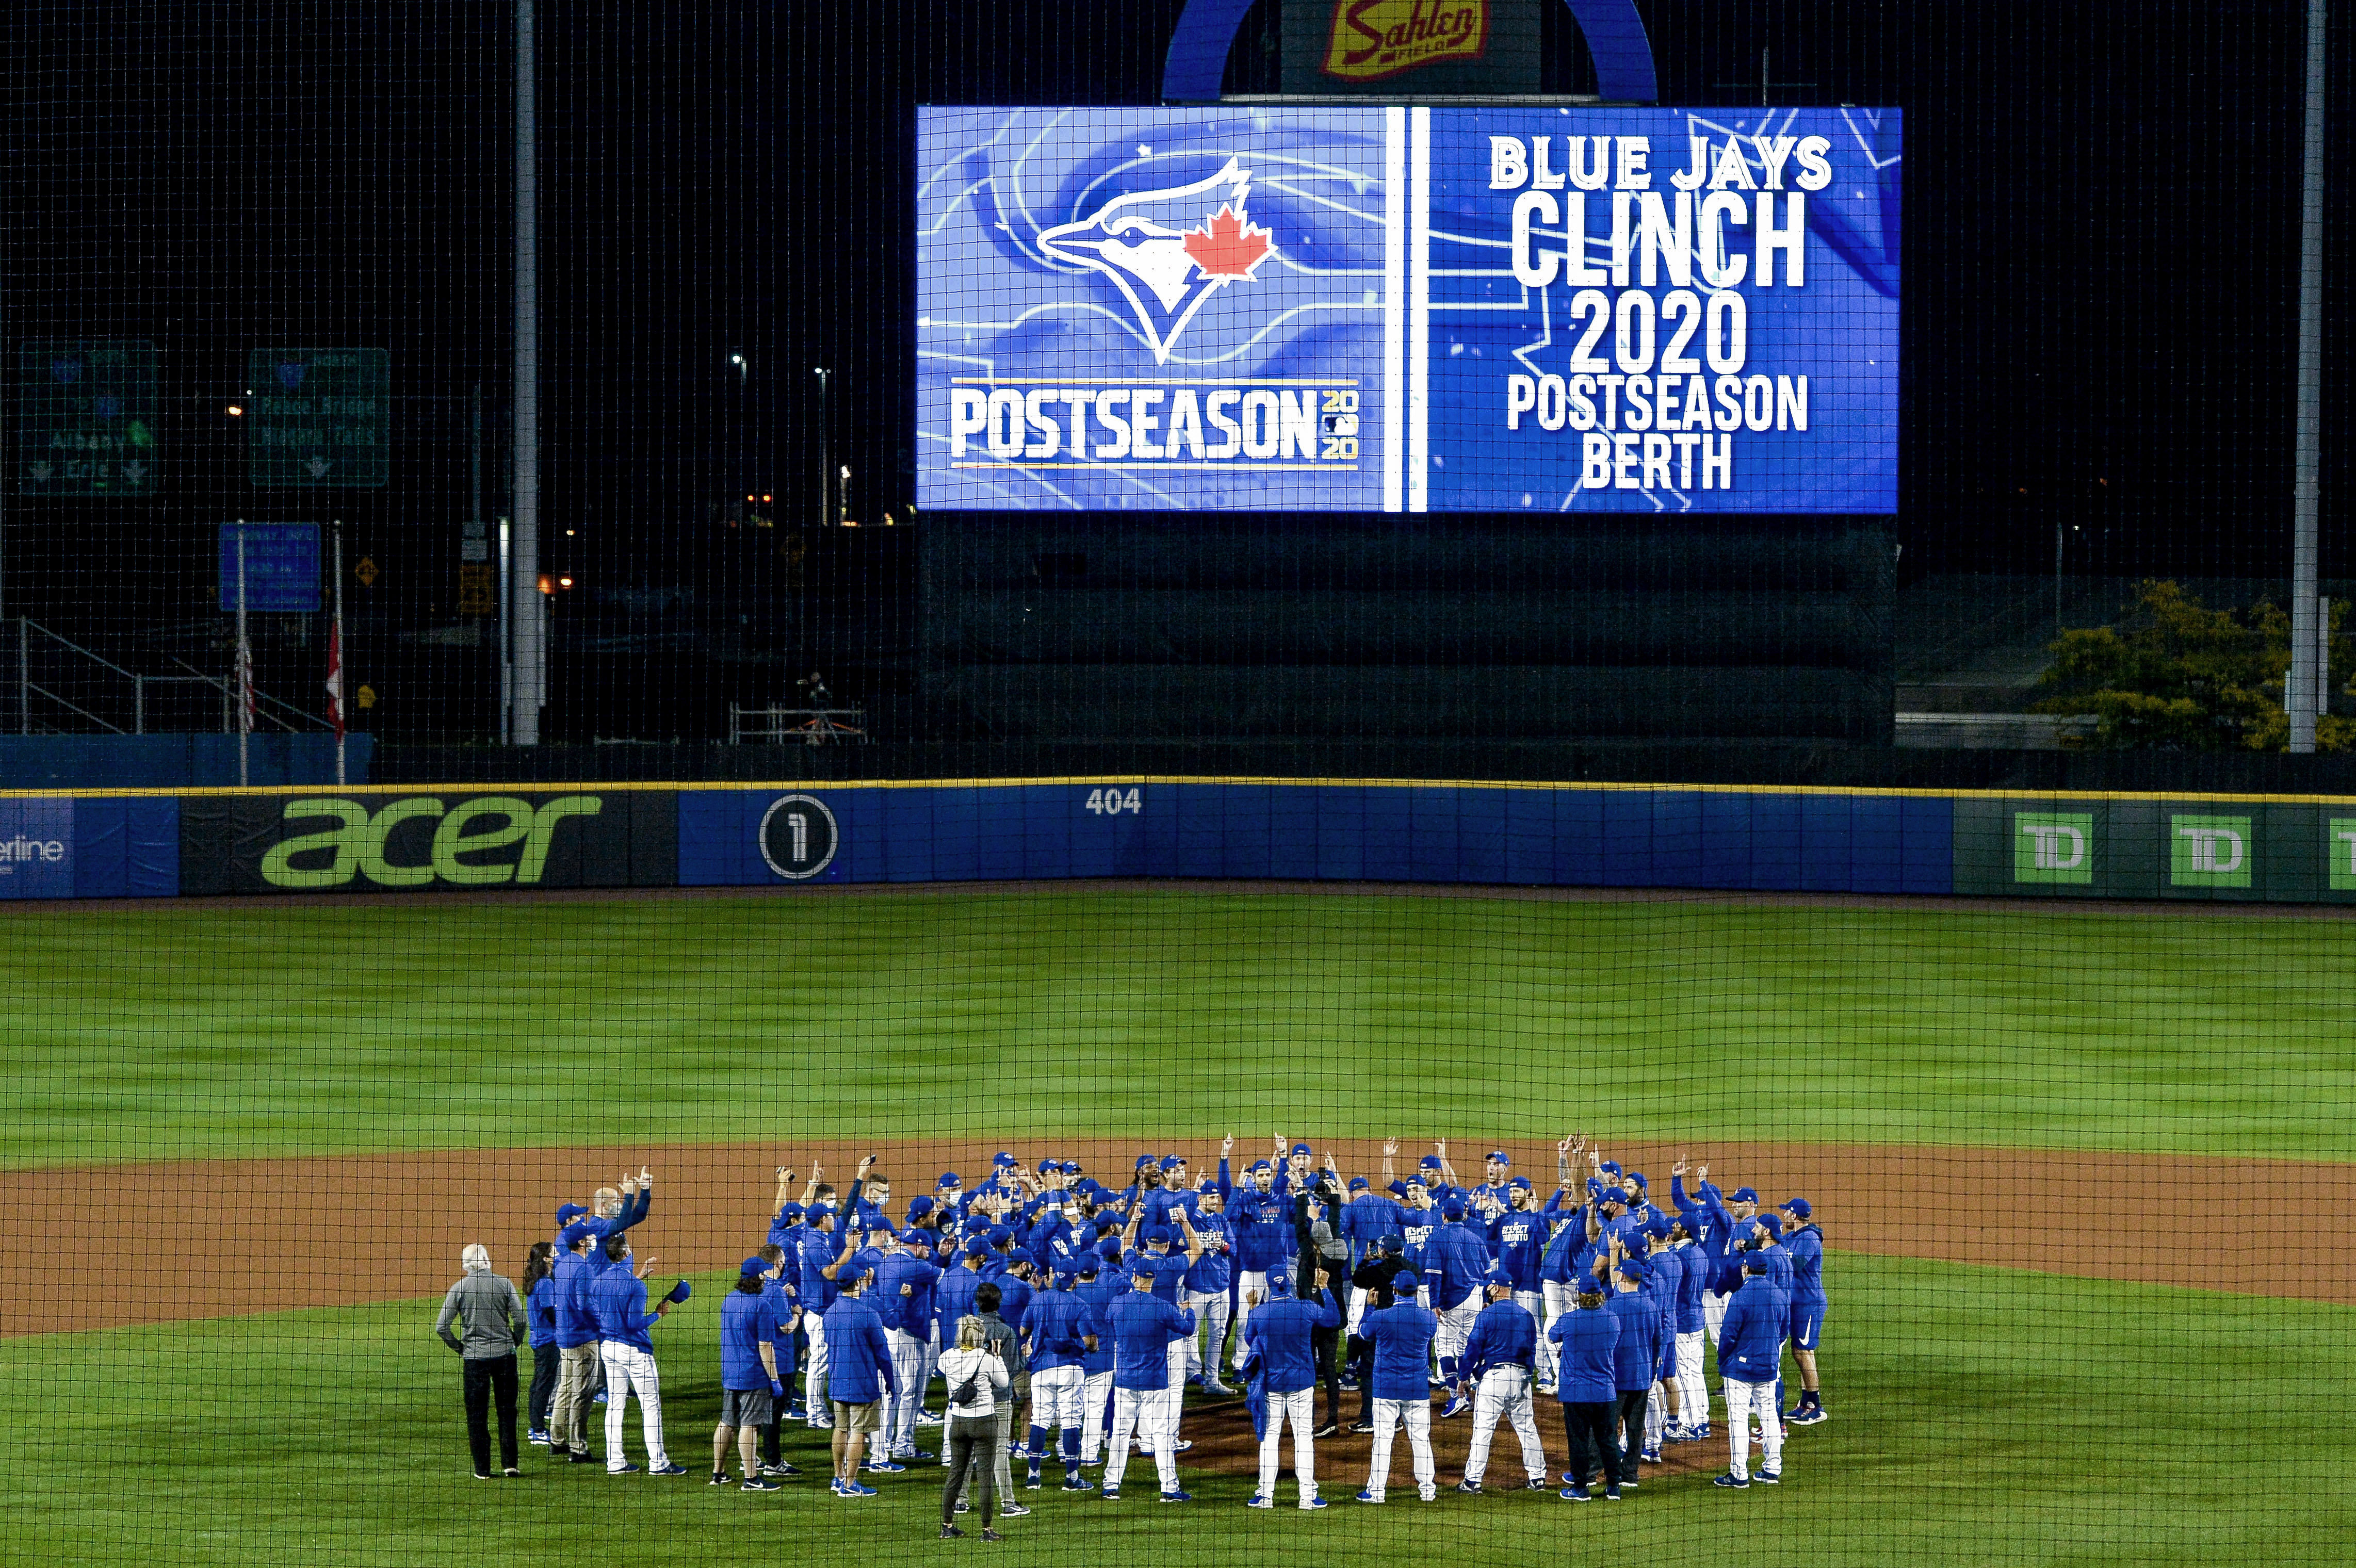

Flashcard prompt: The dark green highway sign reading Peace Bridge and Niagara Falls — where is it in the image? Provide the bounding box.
[245,349,394,489]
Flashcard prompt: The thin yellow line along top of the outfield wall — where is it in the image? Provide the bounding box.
[13,772,2356,805]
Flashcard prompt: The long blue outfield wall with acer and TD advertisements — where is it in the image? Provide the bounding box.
[0,777,2356,904]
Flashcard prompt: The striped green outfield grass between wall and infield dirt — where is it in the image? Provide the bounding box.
[0,885,2356,1165]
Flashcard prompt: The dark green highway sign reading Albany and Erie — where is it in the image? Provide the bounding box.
[17,339,160,497]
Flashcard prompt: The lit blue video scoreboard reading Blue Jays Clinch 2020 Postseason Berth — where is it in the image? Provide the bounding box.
[917,106,1904,513]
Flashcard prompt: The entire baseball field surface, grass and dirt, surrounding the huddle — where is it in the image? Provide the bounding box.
[0,885,2356,1565]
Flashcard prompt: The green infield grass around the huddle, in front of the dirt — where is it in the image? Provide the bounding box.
[0,1257,2356,1568]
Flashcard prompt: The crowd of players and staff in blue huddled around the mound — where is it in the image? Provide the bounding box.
[438,1137,1826,1538]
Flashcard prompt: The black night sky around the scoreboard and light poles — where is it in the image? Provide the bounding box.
[0,0,2356,734]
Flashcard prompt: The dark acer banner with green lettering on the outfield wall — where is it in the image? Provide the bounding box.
[179,789,678,892]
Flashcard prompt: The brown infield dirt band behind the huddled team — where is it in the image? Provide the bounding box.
[13,1128,2356,1335]
